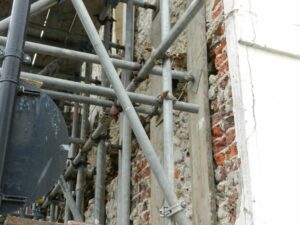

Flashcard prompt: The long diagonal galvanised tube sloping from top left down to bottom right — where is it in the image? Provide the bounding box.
[71,0,189,225]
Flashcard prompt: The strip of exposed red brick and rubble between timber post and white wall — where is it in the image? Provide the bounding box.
[206,0,240,225]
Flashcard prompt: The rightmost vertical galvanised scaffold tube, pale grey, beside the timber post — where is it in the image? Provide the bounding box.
[160,0,175,225]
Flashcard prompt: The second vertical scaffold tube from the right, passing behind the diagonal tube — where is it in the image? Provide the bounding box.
[117,0,134,225]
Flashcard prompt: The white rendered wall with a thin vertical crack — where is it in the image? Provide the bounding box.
[224,0,300,225]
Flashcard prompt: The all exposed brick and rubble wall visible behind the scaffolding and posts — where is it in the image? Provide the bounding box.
[84,0,240,225]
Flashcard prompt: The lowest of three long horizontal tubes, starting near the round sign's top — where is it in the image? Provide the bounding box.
[42,89,153,114]
